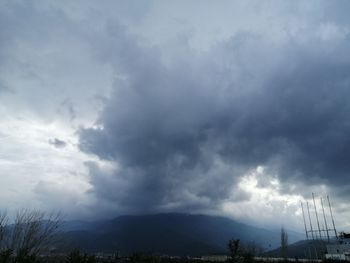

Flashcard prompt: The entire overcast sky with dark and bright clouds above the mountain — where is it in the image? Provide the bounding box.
[0,0,350,232]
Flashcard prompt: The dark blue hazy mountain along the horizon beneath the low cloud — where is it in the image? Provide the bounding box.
[58,214,304,255]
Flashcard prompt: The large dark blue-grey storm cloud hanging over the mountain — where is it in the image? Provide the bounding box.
[80,11,350,211]
